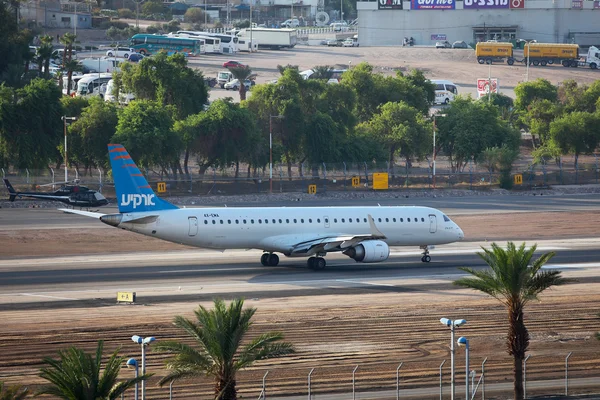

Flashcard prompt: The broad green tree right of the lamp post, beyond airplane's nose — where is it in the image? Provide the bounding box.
[436,96,521,171]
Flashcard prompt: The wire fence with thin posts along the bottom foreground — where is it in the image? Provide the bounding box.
[145,354,600,400]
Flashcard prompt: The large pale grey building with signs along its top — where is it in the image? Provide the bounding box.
[356,0,600,46]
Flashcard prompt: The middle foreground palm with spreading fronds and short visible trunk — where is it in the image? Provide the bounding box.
[154,299,294,400]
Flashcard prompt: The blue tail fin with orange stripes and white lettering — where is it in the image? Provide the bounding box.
[108,144,178,213]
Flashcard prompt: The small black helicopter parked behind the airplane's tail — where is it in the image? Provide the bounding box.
[4,179,108,208]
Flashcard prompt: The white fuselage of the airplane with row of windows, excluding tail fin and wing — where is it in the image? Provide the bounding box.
[109,207,463,255]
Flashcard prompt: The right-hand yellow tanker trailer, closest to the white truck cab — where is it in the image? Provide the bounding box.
[523,43,579,67]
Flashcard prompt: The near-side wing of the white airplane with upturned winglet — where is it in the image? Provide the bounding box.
[265,215,386,256]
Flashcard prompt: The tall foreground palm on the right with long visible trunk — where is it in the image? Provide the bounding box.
[454,242,572,400]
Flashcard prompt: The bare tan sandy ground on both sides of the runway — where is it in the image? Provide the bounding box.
[0,209,600,399]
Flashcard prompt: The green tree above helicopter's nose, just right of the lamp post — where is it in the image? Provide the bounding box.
[69,96,118,174]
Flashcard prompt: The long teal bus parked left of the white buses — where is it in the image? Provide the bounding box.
[129,33,202,56]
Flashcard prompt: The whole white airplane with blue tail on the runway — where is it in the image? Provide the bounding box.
[61,144,464,270]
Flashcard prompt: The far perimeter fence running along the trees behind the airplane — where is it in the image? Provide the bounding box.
[0,156,600,197]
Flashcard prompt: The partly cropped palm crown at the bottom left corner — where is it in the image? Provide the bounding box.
[36,341,152,400]
